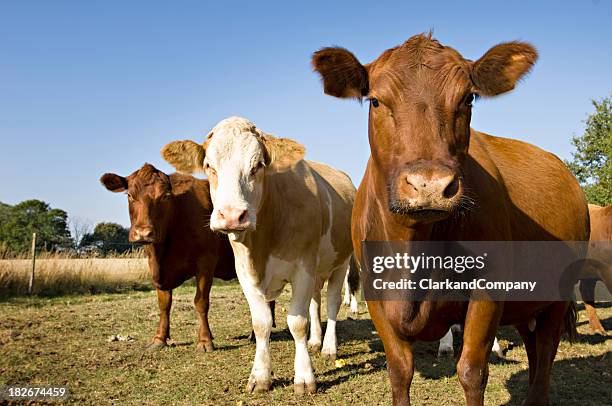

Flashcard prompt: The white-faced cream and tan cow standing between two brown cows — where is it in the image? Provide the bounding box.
[162,117,355,393]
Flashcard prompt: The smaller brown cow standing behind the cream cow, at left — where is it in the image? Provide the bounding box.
[100,164,274,352]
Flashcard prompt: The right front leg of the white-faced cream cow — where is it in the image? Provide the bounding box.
[245,291,272,392]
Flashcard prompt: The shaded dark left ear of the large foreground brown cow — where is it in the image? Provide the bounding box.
[312,48,369,100]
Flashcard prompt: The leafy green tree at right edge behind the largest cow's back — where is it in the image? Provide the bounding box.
[567,96,612,206]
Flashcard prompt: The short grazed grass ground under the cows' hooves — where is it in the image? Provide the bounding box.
[0,283,612,406]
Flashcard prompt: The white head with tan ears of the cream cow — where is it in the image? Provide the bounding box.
[162,117,304,240]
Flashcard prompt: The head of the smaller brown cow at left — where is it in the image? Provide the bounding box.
[100,164,173,244]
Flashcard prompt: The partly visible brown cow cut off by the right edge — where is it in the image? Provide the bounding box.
[580,204,612,335]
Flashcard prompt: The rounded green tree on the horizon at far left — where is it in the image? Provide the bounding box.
[0,200,72,253]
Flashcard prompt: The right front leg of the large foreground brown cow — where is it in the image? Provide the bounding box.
[457,300,503,406]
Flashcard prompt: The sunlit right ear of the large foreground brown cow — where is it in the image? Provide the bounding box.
[472,42,538,96]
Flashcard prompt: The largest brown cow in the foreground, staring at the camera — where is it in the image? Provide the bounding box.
[313,35,589,405]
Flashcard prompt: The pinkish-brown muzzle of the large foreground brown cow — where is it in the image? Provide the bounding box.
[389,164,463,222]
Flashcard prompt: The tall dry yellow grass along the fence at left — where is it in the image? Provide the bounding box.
[0,257,150,296]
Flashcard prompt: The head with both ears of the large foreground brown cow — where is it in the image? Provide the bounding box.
[313,35,537,223]
